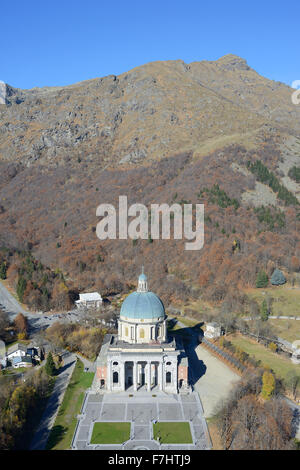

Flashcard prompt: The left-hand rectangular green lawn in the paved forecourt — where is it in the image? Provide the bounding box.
[91,423,130,444]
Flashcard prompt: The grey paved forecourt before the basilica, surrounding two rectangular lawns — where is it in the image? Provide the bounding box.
[73,392,211,450]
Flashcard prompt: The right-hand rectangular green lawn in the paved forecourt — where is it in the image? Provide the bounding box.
[153,421,193,444]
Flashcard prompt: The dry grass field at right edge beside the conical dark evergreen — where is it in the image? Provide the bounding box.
[245,284,300,316]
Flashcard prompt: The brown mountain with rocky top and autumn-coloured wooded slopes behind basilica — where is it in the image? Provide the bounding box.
[0,55,300,308]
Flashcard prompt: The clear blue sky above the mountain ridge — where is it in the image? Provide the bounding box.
[0,0,300,88]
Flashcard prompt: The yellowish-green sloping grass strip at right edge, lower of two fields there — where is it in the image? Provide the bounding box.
[229,335,300,389]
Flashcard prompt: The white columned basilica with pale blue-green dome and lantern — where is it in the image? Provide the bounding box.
[93,272,189,393]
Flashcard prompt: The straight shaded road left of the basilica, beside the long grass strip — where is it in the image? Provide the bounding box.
[30,352,76,450]
